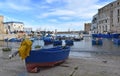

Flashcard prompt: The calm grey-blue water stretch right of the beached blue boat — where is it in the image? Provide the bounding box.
[70,37,120,57]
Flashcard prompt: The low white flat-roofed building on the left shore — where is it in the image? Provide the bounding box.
[4,22,24,33]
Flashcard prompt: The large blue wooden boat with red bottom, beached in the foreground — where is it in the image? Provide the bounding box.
[25,46,70,72]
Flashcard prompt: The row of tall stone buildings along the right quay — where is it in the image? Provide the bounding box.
[91,0,120,33]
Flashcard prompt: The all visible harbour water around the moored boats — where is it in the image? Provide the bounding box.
[0,37,120,57]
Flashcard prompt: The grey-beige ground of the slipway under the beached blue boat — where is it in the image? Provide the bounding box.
[0,50,120,76]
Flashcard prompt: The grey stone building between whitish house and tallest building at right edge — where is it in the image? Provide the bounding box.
[98,4,112,33]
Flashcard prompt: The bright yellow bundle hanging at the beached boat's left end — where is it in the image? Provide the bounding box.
[18,39,32,60]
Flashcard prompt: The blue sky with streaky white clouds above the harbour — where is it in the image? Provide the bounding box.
[0,0,115,31]
